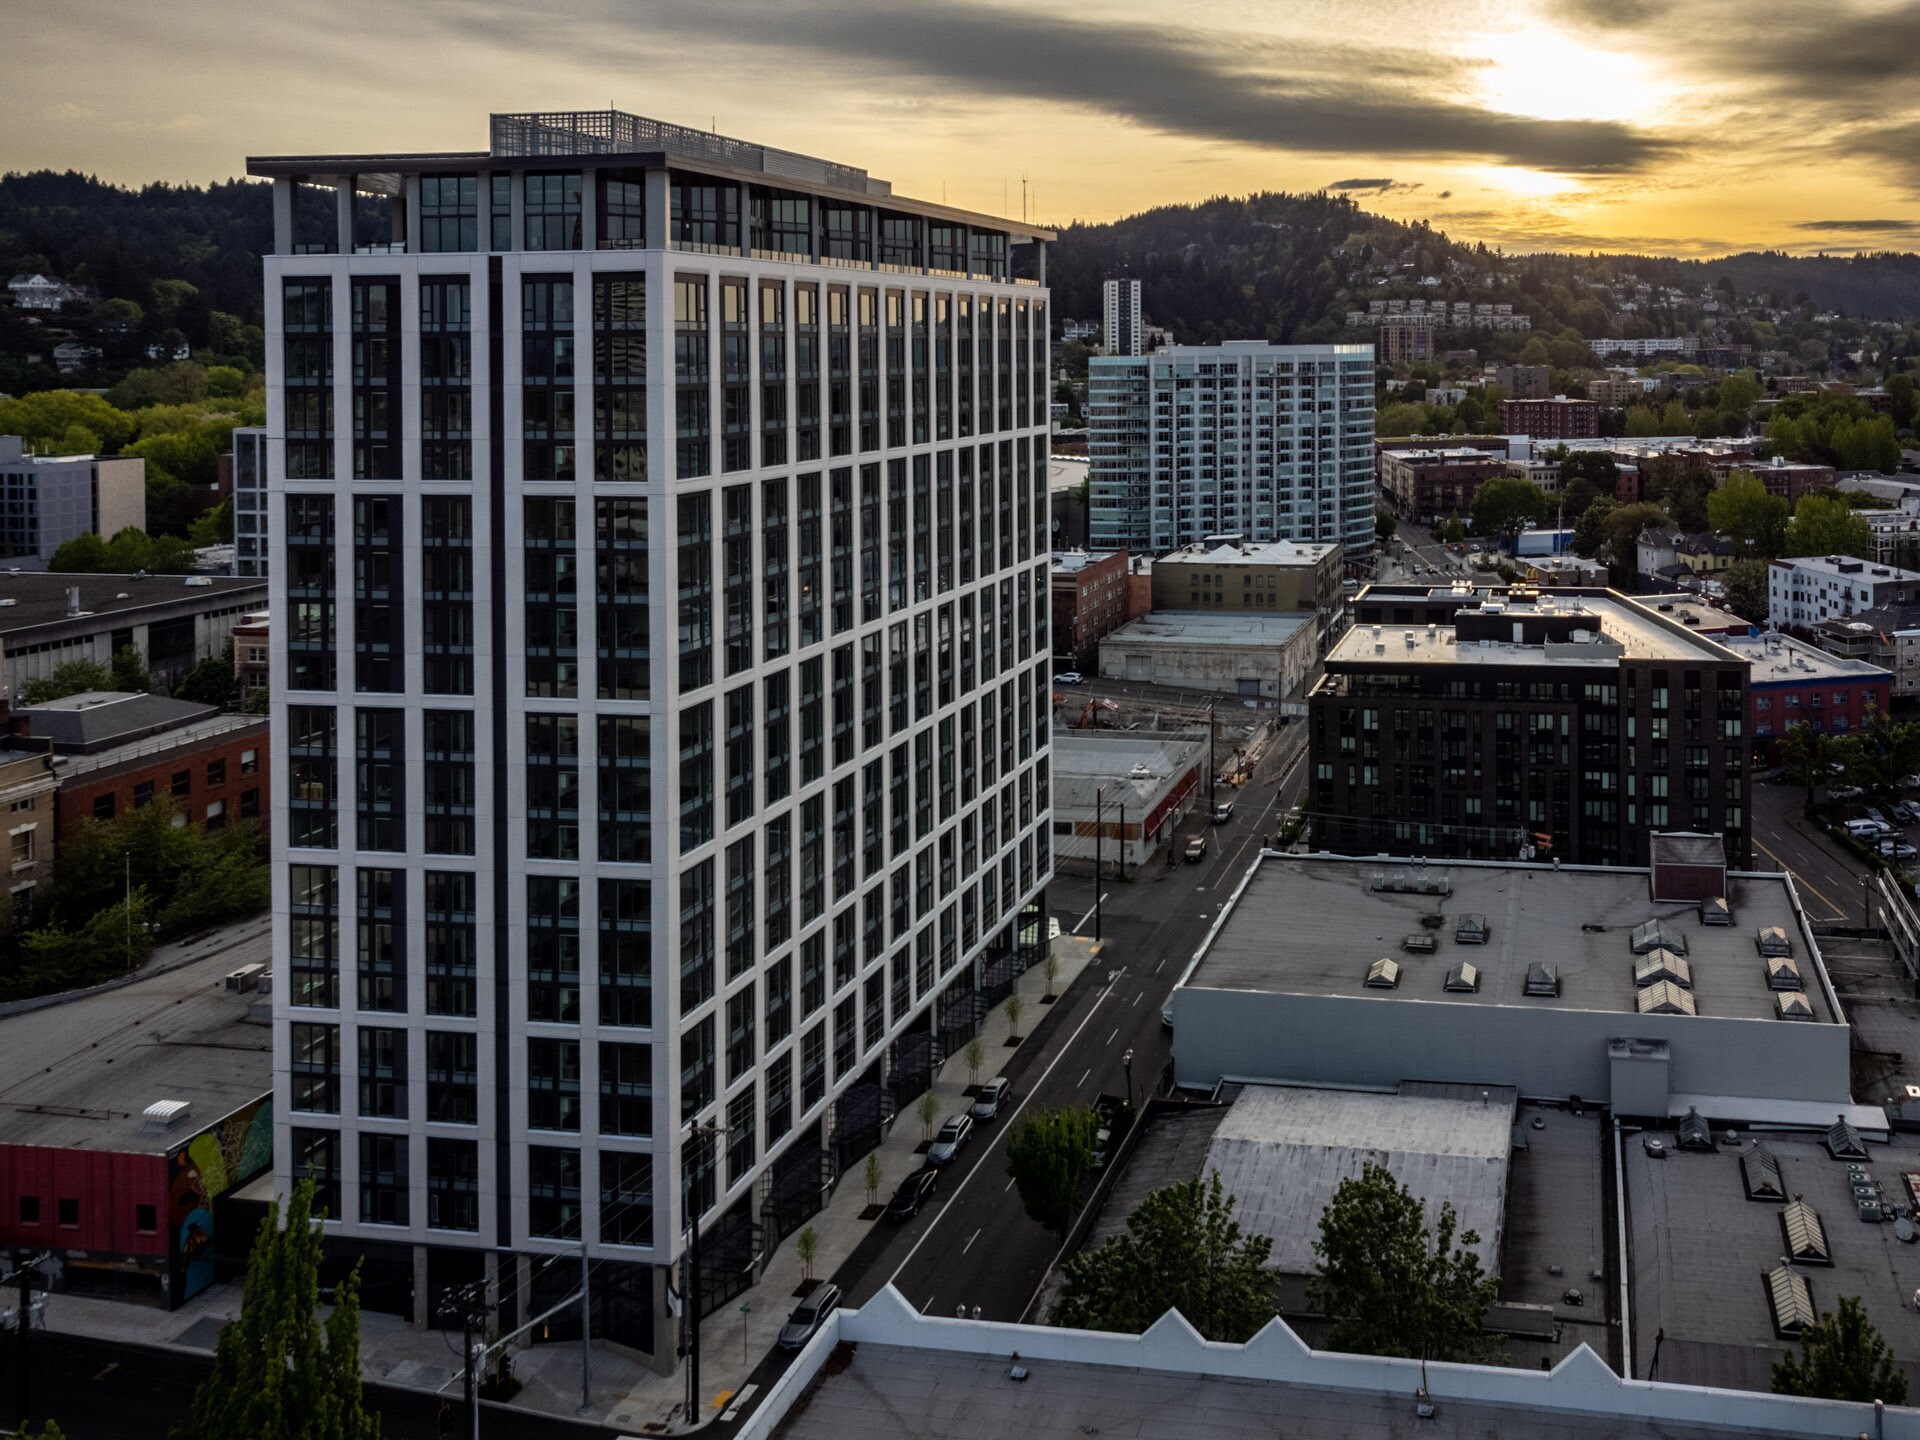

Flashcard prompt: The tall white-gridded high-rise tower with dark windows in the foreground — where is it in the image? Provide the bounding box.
[250,111,1052,1369]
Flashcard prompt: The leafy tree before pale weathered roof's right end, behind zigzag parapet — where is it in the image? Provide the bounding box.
[1308,1164,1500,1359]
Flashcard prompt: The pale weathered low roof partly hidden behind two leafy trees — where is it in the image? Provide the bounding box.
[1202,1085,1515,1275]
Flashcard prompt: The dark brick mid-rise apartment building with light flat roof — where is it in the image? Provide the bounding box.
[1308,586,1751,868]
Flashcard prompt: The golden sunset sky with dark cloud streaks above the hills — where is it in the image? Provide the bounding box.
[15,0,1920,255]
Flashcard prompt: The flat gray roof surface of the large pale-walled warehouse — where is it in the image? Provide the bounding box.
[1183,852,1834,1023]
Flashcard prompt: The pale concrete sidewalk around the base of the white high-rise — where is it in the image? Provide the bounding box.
[46,935,1100,1434]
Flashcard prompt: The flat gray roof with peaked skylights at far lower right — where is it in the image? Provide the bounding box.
[1624,1131,1920,1390]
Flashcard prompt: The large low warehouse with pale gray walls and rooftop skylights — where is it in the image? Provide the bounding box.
[1171,837,1885,1131]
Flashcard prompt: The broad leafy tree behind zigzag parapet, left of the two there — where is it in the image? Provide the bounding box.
[1048,1171,1279,1344]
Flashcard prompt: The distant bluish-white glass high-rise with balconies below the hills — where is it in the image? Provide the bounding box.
[1087,340,1373,555]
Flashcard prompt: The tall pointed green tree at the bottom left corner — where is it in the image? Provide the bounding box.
[180,1181,380,1440]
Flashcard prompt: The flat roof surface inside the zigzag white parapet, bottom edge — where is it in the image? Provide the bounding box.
[776,1344,1758,1440]
